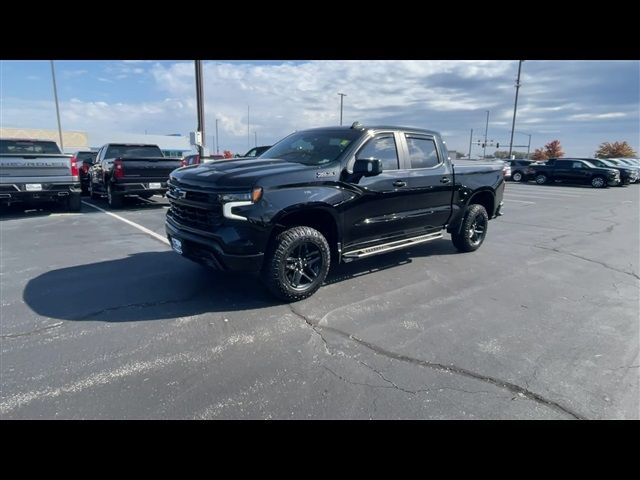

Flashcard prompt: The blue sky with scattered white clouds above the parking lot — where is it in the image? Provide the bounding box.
[0,60,640,156]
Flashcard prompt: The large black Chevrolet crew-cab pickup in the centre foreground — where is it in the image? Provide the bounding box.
[165,123,504,301]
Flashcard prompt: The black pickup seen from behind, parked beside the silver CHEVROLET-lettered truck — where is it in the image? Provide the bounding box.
[89,143,181,208]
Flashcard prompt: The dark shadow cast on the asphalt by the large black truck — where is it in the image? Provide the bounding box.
[23,240,457,322]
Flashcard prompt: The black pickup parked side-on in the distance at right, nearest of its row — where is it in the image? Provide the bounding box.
[529,158,620,188]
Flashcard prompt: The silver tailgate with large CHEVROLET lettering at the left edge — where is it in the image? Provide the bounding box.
[0,153,78,185]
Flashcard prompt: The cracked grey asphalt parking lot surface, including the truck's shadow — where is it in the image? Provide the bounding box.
[0,183,640,419]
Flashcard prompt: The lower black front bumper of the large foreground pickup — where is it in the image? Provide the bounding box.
[165,219,264,273]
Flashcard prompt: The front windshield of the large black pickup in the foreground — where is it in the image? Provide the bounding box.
[261,129,362,165]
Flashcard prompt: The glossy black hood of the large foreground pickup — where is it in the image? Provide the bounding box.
[170,158,318,190]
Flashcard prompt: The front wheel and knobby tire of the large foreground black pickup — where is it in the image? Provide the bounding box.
[263,227,331,302]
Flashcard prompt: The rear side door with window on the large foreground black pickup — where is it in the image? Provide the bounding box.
[400,133,453,230]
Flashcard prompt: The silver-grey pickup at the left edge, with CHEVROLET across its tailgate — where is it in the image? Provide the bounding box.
[0,138,81,212]
